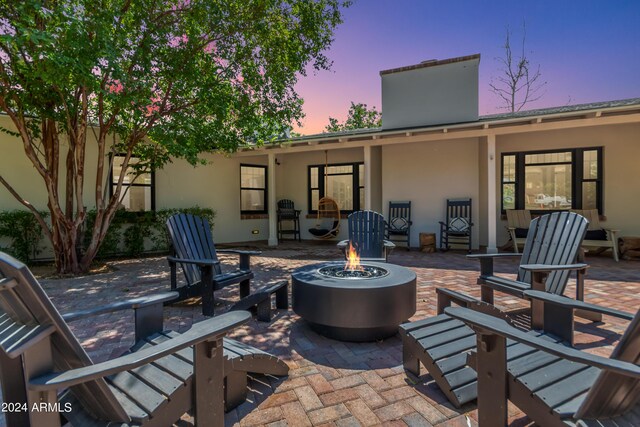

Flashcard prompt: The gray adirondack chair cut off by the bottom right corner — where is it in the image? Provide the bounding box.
[445,308,640,427]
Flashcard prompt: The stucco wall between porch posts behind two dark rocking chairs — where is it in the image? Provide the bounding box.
[382,138,480,248]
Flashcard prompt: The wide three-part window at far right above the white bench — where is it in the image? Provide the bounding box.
[502,147,603,214]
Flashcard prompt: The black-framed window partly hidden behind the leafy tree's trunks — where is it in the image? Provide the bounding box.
[109,155,155,212]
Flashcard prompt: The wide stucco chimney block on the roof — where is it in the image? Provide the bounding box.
[380,54,480,129]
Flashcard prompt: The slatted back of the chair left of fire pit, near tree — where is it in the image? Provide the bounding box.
[167,213,222,284]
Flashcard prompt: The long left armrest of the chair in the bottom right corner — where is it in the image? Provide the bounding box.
[444,307,640,379]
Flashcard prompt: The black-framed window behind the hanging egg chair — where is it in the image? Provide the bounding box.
[309,163,364,213]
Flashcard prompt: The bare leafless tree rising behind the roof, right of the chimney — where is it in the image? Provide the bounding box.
[489,23,547,113]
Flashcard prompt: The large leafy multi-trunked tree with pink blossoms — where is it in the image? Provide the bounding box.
[0,0,348,273]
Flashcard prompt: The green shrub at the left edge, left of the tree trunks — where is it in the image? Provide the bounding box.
[0,210,49,264]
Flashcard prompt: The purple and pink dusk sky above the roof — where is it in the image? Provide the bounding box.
[296,0,640,134]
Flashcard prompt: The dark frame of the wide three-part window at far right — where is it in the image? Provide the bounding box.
[500,146,604,215]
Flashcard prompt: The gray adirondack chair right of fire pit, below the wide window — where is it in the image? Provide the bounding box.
[468,212,600,328]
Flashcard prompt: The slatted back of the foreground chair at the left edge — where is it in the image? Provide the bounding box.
[0,252,130,422]
